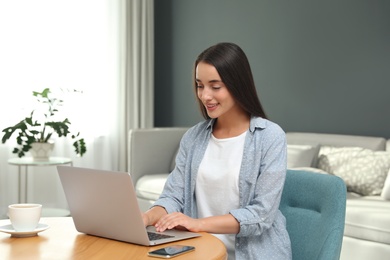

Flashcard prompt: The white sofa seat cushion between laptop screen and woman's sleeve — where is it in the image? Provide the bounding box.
[135,173,169,201]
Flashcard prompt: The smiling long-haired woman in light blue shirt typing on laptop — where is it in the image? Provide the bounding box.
[144,43,291,260]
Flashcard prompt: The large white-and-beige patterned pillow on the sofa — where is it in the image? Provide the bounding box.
[318,147,390,196]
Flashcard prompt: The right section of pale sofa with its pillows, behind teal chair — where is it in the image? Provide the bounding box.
[287,133,390,260]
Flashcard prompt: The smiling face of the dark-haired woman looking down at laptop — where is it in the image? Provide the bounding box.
[195,62,238,118]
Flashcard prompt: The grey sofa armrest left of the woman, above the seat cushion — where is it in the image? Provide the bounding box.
[128,127,188,185]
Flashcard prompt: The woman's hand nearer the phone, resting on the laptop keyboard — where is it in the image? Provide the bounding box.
[154,212,202,232]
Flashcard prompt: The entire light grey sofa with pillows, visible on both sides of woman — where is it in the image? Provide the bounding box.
[129,128,390,260]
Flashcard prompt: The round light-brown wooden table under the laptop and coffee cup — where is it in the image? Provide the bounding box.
[0,217,227,260]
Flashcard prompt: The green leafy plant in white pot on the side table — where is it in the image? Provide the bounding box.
[1,88,87,160]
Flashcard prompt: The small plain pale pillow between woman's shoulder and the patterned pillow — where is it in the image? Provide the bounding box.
[287,144,319,169]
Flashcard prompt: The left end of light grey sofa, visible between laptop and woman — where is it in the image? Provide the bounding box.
[128,127,188,211]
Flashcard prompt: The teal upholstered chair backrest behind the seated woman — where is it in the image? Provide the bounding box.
[280,170,346,260]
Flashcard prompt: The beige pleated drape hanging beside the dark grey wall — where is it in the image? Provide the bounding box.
[119,0,154,173]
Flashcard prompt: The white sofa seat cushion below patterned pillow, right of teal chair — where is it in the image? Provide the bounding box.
[344,193,390,245]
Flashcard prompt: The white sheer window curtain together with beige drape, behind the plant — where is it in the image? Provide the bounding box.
[0,0,154,218]
